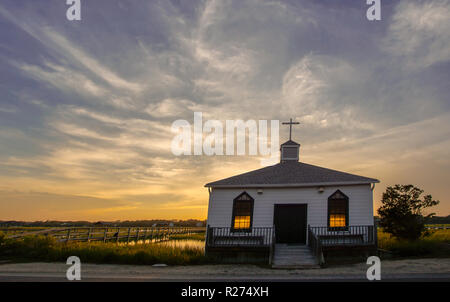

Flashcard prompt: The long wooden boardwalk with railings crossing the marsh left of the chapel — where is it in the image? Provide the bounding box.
[3,227,205,242]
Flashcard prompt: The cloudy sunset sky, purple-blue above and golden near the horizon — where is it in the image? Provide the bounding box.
[0,0,450,221]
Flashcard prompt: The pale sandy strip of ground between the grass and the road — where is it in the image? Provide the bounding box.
[0,258,450,281]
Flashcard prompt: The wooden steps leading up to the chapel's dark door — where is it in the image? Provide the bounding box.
[272,244,320,269]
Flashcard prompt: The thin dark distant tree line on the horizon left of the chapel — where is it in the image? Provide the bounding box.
[0,219,206,227]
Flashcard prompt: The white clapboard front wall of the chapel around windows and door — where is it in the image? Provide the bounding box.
[208,185,373,227]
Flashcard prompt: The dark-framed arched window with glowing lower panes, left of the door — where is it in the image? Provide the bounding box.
[231,192,254,231]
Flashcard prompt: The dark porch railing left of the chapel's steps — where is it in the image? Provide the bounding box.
[206,226,274,248]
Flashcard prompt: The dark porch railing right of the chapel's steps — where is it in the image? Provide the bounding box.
[308,225,376,246]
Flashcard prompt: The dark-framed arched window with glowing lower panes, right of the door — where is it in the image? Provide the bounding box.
[328,190,348,230]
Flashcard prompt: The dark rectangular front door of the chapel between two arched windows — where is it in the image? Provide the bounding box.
[274,204,306,243]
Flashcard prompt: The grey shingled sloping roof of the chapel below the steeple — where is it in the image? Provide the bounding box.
[205,161,379,188]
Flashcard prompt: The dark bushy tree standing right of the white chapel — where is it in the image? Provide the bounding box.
[378,184,439,241]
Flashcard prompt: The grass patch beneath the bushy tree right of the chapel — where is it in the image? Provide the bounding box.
[378,230,450,257]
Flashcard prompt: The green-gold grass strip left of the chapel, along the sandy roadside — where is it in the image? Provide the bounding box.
[0,234,209,265]
